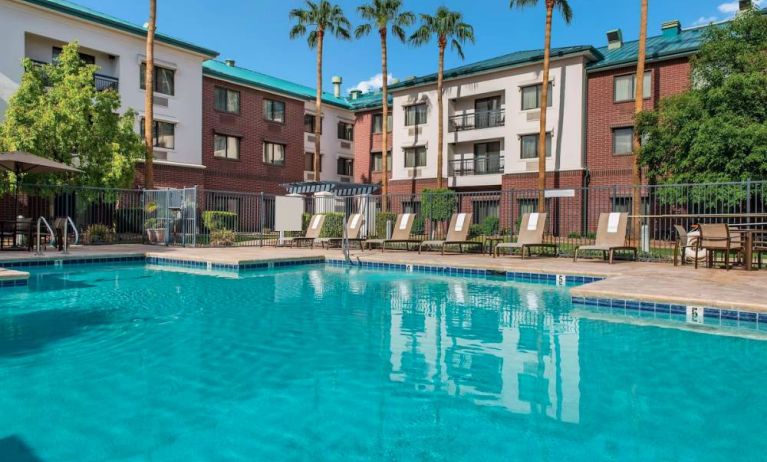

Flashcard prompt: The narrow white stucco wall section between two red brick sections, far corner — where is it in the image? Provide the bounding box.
[304,101,354,181]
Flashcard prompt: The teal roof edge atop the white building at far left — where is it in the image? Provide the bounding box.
[22,0,218,58]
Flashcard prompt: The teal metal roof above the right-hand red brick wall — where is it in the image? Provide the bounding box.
[588,26,709,71]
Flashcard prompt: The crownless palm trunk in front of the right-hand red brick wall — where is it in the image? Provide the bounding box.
[631,0,647,241]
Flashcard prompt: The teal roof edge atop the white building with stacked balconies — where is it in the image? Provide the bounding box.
[389,45,602,90]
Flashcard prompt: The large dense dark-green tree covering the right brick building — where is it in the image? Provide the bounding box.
[637,11,767,183]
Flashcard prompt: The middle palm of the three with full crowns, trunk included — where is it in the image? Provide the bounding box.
[354,0,415,206]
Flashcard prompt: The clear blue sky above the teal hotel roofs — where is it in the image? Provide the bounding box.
[73,0,756,90]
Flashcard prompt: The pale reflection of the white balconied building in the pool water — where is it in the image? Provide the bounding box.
[390,281,580,423]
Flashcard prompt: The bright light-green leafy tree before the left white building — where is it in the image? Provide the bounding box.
[0,42,144,188]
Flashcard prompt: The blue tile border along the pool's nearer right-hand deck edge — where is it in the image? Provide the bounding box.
[572,296,767,331]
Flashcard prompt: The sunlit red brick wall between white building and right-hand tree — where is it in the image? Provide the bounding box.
[586,58,690,186]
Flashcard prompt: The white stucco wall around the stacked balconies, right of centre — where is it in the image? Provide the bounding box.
[392,56,586,186]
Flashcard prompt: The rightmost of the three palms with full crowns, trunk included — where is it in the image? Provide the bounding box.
[410,6,474,189]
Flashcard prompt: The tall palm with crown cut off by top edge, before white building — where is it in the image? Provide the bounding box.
[509,0,573,212]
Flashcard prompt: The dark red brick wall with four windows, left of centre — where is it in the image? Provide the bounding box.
[202,77,304,193]
